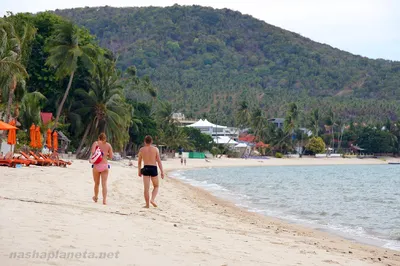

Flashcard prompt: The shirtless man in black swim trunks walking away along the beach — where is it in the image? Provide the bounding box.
[138,136,164,208]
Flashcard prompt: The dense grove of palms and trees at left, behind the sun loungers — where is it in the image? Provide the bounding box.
[0,12,212,158]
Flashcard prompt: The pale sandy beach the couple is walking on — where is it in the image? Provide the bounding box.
[0,158,400,266]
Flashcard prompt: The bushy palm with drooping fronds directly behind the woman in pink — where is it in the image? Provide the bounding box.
[73,56,132,157]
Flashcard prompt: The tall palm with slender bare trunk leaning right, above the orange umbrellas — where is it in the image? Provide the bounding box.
[46,22,99,128]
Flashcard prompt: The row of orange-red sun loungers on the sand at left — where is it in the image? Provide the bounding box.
[0,151,71,167]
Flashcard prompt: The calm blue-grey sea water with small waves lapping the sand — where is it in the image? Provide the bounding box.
[173,165,400,250]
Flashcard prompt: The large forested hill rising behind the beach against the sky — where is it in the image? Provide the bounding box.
[56,5,400,124]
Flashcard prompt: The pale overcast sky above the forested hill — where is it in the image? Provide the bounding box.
[0,0,400,61]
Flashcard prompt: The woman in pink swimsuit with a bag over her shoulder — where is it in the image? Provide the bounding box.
[91,133,113,205]
